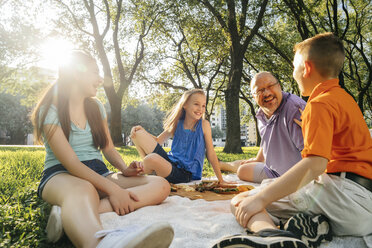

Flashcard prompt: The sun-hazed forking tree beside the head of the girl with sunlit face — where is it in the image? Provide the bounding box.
[56,0,163,144]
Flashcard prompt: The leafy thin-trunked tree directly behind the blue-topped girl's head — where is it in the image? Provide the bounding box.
[141,1,228,119]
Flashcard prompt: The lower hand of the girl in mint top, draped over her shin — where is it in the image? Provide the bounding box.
[108,187,139,215]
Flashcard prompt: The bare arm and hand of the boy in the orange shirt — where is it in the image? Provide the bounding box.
[235,156,328,227]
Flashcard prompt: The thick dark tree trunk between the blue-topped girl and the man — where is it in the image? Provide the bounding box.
[223,48,244,153]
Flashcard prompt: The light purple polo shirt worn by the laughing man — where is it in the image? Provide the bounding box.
[256,92,306,177]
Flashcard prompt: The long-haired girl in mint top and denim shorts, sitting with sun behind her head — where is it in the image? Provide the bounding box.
[33,51,173,247]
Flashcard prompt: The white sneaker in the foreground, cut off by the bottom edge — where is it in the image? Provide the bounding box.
[95,222,174,248]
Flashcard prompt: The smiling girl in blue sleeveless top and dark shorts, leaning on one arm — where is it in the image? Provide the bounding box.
[131,89,230,184]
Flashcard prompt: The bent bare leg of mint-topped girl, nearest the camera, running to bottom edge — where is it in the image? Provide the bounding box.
[42,173,102,247]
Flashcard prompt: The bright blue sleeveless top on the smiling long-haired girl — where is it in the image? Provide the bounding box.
[168,119,205,180]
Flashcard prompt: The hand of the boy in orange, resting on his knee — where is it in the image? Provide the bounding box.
[235,195,265,228]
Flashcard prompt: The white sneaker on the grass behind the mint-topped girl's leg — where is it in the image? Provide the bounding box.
[45,205,63,243]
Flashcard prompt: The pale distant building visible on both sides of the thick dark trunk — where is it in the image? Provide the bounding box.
[210,105,257,146]
